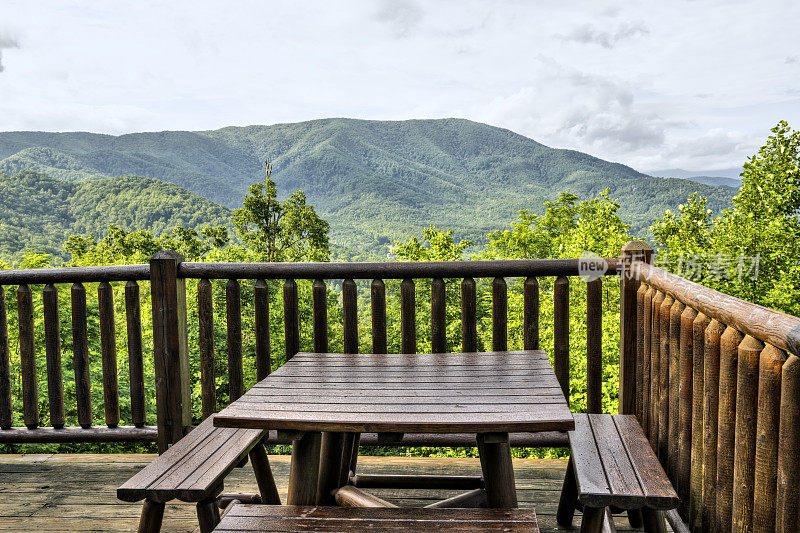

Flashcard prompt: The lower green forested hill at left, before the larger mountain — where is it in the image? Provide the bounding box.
[0,171,230,258]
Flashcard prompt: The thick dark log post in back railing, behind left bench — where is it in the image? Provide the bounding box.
[150,251,192,453]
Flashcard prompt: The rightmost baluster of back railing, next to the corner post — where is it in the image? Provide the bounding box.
[586,278,603,413]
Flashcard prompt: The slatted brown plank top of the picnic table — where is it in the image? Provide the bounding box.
[214,350,574,433]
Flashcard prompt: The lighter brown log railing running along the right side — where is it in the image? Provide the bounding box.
[632,261,800,532]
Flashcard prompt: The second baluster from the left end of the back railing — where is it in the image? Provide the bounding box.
[17,285,39,429]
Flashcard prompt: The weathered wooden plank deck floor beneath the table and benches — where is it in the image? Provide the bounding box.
[0,454,648,532]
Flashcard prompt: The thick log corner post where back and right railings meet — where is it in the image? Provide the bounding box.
[619,241,653,414]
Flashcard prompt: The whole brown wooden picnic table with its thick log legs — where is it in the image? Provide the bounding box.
[214,350,574,508]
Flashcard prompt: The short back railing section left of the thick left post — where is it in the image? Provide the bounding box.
[0,265,157,443]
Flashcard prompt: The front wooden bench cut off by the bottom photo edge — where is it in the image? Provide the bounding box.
[214,504,539,533]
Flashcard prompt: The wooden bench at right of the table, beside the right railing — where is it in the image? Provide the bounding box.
[556,414,680,532]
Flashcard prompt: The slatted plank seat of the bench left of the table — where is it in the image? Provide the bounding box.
[117,416,264,502]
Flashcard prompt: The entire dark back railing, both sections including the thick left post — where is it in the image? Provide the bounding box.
[0,252,620,450]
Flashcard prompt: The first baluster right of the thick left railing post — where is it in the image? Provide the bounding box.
[197,279,217,420]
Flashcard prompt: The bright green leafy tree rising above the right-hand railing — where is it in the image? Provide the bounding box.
[653,121,800,315]
